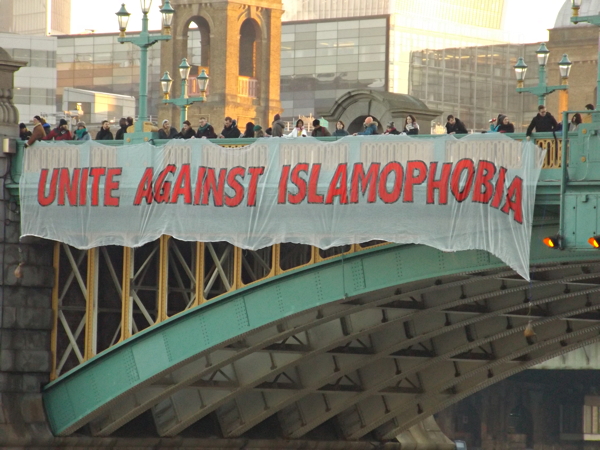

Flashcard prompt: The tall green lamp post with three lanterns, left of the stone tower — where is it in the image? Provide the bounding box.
[116,0,175,138]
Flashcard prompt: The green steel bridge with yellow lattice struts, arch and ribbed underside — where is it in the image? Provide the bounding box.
[14,130,600,441]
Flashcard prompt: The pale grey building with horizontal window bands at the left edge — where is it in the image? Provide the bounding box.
[0,33,56,123]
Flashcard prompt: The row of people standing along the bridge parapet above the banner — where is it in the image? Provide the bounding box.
[19,104,594,147]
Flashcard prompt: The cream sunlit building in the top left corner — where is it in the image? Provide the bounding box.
[0,0,71,36]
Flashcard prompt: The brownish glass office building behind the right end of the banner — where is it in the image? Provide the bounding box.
[409,44,539,132]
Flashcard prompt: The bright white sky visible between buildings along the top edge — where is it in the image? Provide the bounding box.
[71,0,565,42]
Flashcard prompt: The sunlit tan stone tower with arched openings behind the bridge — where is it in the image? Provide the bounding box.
[159,0,283,133]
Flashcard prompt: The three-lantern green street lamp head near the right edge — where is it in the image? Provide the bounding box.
[514,43,577,105]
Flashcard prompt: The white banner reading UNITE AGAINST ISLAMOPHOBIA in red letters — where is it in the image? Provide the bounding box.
[20,134,544,279]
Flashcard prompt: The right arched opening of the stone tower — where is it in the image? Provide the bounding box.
[238,19,260,97]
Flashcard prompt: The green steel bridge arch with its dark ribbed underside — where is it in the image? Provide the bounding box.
[44,226,600,440]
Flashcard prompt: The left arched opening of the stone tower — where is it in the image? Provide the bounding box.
[186,17,210,97]
